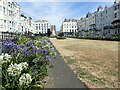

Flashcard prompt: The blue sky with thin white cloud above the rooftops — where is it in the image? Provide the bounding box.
[18,2,113,30]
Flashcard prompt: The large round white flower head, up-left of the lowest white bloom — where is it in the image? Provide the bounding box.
[7,63,23,76]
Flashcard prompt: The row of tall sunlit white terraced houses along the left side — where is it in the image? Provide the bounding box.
[0,0,35,33]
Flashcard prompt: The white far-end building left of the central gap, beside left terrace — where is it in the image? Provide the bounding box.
[35,20,50,34]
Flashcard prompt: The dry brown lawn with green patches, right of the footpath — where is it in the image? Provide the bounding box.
[50,38,118,88]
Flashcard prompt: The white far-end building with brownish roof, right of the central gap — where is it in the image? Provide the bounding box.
[62,19,78,34]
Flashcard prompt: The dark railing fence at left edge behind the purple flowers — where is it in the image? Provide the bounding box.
[0,32,16,41]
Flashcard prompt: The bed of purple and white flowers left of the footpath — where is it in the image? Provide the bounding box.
[0,36,56,89]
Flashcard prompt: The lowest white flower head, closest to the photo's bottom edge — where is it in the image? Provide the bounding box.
[19,73,32,85]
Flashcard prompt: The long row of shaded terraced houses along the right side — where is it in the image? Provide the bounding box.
[78,0,120,36]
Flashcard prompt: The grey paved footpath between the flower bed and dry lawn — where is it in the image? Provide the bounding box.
[45,47,88,90]
